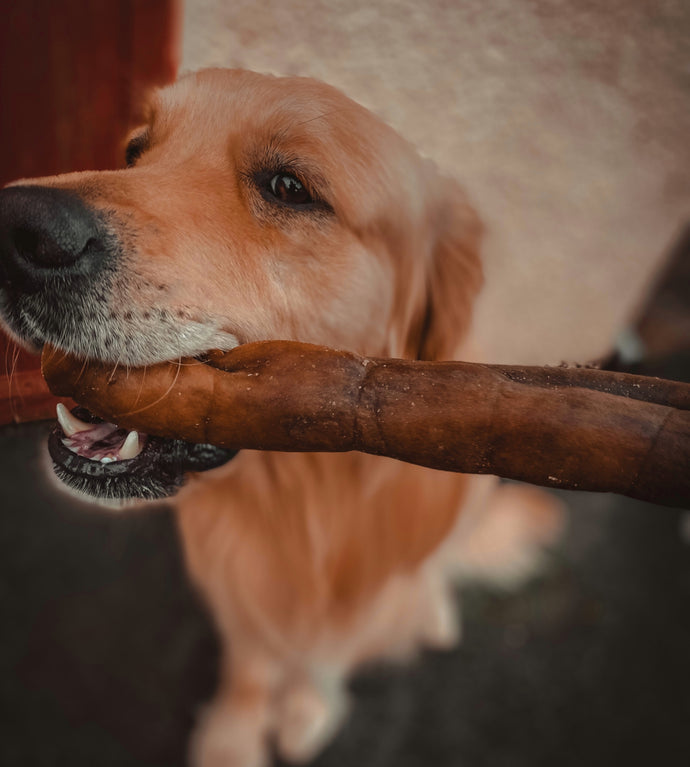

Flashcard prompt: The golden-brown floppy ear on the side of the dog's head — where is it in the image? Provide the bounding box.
[416,177,483,360]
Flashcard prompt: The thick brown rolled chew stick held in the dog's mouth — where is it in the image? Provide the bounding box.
[43,341,690,506]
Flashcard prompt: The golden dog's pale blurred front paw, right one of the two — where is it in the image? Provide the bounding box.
[276,669,349,763]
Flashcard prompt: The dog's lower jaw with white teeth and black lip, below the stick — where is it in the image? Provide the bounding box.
[48,405,236,502]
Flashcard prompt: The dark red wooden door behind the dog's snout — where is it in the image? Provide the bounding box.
[0,0,181,424]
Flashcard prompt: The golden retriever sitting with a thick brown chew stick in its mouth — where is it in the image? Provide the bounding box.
[0,69,559,767]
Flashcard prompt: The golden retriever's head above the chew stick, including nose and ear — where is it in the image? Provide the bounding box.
[0,70,481,500]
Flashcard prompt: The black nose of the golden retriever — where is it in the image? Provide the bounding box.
[0,186,104,281]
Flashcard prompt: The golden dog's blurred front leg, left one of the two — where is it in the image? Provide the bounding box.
[190,647,280,767]
